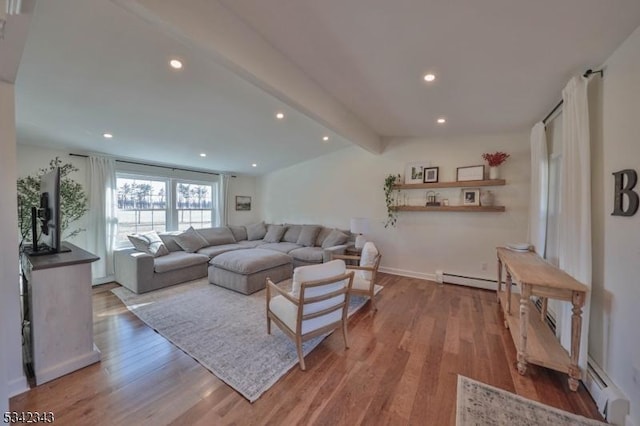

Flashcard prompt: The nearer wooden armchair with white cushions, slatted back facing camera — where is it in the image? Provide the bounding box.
[267,260,354,370]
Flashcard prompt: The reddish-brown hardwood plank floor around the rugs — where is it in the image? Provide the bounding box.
[10,274,600,425]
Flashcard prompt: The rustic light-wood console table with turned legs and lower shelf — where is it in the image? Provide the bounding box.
[497,247,588,391]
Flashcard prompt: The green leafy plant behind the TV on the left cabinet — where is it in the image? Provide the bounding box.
[17,157,89,245]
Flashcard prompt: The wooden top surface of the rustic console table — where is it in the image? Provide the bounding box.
[497,247,589,293]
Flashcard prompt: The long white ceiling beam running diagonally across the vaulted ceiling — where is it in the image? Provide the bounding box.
[112,0,383,154]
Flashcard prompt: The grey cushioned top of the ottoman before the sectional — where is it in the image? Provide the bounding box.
[209,248,291,275]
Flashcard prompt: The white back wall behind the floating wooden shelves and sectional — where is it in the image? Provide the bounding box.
[260,133,530,279]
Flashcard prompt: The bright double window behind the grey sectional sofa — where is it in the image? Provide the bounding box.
[116,173,218,246]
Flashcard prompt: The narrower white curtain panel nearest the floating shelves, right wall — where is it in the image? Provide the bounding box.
[529,122,549,258]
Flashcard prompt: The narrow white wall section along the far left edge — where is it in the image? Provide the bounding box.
[0,81,27,406]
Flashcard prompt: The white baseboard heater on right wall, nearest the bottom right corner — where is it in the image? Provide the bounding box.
[584,357,629,426]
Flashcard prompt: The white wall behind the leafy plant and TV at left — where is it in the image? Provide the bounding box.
[18,143,88,249]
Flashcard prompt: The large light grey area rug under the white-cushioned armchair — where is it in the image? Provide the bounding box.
[111,278,382,402]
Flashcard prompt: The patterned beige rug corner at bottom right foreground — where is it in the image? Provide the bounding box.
[456,375,607,426]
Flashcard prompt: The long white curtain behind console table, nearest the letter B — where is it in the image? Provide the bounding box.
[558,76,591,372]
